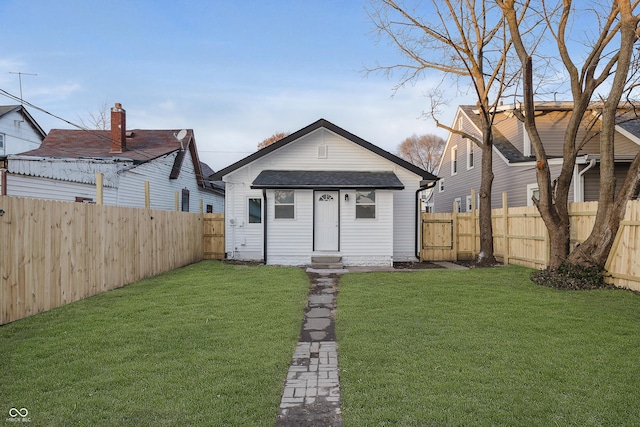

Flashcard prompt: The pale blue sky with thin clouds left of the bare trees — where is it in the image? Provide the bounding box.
[0,0,469,170]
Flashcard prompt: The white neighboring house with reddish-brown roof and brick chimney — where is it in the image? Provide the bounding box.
[4,104,224,212]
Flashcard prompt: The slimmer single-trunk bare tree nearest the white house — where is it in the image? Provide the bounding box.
[369,0,520,264]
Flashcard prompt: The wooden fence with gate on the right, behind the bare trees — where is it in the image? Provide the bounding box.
[420,195,640,290]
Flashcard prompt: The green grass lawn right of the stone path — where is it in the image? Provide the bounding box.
[337,266,640,426]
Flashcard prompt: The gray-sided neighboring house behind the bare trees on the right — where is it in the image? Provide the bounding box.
[429,102,640,212]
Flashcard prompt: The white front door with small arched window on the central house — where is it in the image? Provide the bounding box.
[313,191,340,251]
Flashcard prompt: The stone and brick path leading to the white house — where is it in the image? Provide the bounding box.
[276,270,346,427]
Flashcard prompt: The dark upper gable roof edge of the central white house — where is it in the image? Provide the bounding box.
[210,119,437,181]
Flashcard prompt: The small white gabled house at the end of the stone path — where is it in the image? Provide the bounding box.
[210,119,437,266]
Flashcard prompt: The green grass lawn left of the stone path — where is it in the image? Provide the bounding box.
[0,261,309,426]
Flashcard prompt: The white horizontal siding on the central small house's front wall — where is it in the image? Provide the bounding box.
[224,129,421,265]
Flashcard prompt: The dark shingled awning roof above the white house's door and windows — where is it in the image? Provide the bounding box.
[251,170,404,190]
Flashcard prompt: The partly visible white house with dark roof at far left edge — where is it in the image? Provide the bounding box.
[0,105,47,194]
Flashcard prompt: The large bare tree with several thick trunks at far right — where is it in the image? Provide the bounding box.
[496,0,640,270]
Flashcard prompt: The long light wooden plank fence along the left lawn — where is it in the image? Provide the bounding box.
[0,196,208,324]
